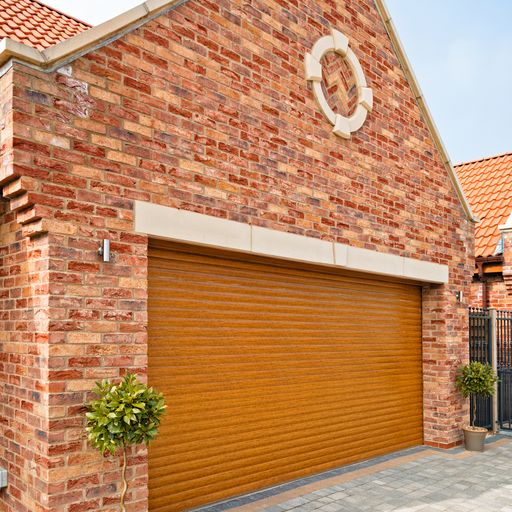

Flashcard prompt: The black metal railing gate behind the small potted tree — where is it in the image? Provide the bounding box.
[469,308,512,430]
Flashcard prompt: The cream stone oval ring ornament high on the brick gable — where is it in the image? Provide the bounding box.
[304,29,373,139]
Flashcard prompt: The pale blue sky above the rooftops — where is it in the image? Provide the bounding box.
[44,0,512,163]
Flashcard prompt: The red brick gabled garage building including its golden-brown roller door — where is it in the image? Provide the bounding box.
[0,0,475,512]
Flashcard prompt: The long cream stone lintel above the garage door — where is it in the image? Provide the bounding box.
[135,201,448,284]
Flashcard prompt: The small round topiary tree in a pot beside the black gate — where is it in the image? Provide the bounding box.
[456,361,498,452]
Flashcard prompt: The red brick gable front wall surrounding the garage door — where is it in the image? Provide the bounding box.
[0,0,473,512]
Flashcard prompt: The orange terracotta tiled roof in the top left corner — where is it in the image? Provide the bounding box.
[0,0,91,50]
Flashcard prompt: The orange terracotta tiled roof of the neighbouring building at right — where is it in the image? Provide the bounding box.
[455,153,512,256]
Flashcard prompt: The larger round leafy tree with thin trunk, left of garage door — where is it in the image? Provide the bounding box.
[86,373,166,512]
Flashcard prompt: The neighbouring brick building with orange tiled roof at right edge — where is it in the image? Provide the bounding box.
[456,153,512,309]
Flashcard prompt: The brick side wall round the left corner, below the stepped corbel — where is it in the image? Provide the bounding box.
[0,226,50,512]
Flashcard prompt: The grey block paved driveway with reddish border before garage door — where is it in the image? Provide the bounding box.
[200,436,512,512]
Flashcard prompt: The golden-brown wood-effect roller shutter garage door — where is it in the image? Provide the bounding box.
[149,242,423,512]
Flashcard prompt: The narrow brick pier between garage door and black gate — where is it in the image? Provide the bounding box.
[422,285,469,448]
